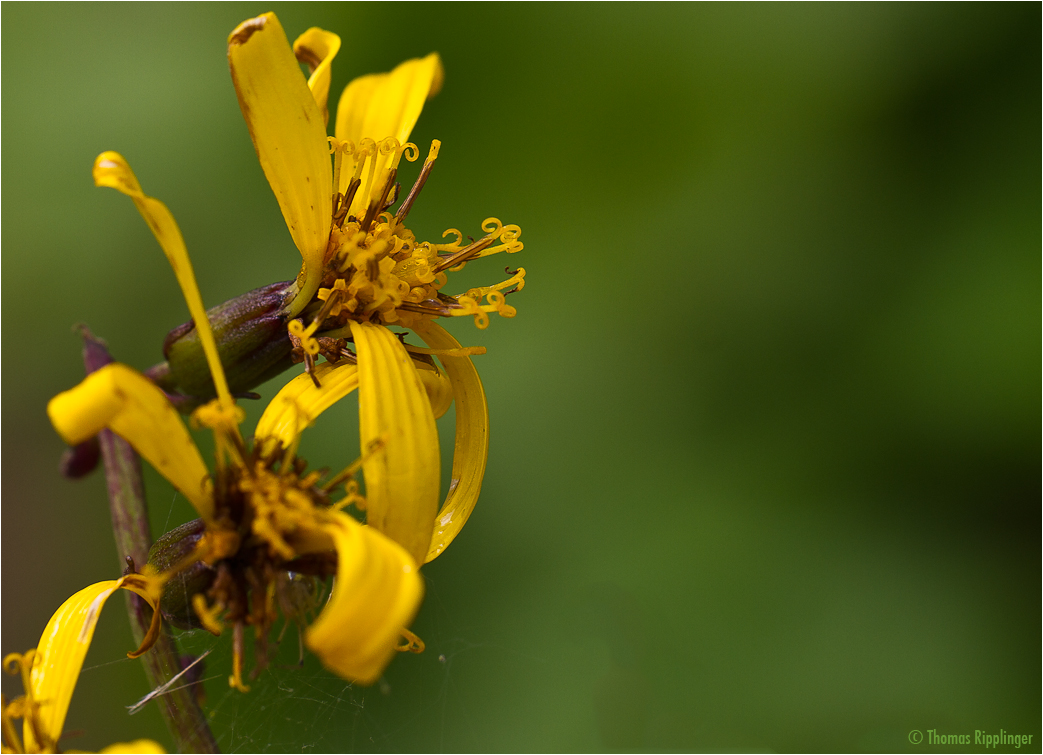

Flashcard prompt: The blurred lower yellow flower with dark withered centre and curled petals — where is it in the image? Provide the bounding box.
[48,308,430,690]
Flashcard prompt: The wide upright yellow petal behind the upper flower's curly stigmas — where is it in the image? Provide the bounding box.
[336,52,445,215]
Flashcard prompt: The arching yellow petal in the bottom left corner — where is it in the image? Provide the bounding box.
[22,578,159,752]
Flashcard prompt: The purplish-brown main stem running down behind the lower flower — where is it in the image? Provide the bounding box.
[80,326,219,753]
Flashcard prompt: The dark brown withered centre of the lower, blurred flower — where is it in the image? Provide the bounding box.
[173,410,365,690]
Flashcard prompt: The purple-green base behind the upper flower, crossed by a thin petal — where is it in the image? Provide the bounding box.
[148,282,293,410]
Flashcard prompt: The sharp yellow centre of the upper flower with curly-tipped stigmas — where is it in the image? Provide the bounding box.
[289,137,525,369]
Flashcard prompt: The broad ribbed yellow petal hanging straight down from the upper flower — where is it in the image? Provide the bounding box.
[349,321,440,563]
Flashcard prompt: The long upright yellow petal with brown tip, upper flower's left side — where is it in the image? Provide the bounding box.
[228,14,333,306]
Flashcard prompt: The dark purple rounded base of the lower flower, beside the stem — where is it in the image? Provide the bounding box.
[148,519,217,629]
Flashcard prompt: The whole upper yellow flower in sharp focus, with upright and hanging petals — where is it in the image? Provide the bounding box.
[228,14,525,562]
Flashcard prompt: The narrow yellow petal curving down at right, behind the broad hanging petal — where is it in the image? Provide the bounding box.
[413,321,489,562]
